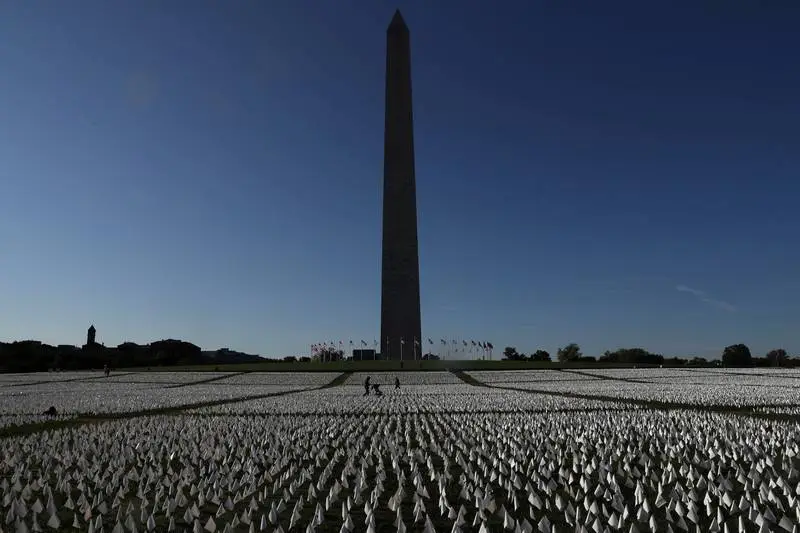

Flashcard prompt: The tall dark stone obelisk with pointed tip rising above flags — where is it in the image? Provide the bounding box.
[381,11,422,360]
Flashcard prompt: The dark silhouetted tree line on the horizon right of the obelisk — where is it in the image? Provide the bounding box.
[503,342,800,367]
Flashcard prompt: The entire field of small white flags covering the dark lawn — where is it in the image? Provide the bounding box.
[0,368,800,533]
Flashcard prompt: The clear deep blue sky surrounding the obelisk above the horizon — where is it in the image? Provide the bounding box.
[0,0,800,356]
